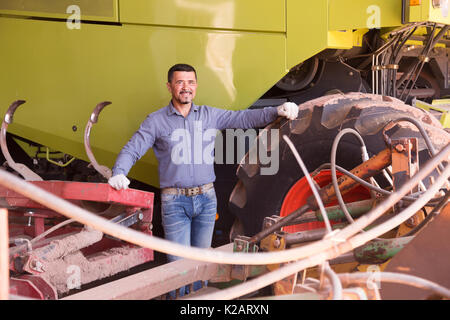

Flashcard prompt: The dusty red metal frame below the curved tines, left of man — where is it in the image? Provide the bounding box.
[0,181,154,299]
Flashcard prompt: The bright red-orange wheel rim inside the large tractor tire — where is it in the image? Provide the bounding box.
[280,170,370,233]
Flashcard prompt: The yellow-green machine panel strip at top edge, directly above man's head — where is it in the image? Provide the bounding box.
[120,0,286,32]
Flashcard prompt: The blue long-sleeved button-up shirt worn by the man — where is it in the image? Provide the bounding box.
[112,102,278,188]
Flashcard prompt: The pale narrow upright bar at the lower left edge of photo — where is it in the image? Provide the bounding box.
[0,209,9,300]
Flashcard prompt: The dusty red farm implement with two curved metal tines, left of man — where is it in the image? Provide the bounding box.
[0,100,154,299]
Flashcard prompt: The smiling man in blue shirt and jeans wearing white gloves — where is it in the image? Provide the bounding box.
[108,64,298,296]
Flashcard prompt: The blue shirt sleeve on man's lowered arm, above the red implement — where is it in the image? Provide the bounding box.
[112,114,156,176]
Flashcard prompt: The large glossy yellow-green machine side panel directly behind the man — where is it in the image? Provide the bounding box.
[0,17,286,185]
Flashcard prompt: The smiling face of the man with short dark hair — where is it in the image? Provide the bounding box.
[167,71,197,104]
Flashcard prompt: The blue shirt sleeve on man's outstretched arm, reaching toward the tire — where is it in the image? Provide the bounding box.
[214,107,278,130]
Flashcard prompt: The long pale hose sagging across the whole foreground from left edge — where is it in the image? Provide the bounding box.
[0,145,450,265]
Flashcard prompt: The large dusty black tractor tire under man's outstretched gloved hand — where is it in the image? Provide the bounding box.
[229,93,450,238]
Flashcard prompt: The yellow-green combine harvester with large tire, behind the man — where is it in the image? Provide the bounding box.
[0,0,450,300]
